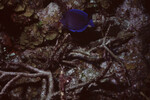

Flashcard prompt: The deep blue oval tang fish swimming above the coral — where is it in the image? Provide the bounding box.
[60,9,94,32]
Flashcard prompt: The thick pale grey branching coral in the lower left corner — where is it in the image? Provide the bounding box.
[0,63,53,100]
